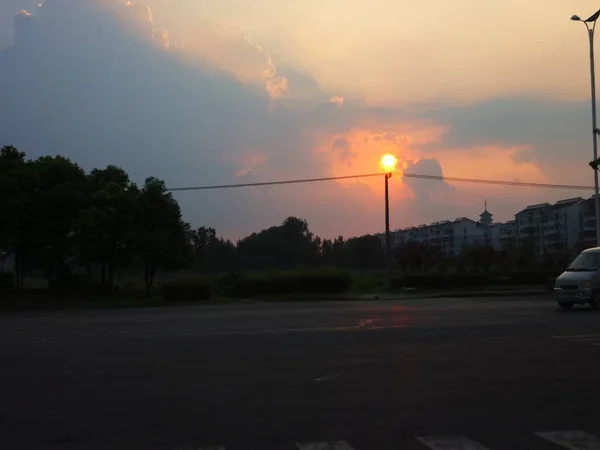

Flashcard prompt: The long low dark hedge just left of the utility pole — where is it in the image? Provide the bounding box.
[231,270,352,297]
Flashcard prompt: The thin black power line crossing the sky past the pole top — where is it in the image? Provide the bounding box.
[168,172,594,192]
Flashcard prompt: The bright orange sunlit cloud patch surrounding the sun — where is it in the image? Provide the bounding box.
[315,118,556,227]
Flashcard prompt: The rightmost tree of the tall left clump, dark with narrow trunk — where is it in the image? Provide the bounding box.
[136,177,190,293]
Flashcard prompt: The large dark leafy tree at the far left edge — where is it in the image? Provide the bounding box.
[0,150,86,287]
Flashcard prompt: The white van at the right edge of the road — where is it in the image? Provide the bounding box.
[554,247,600,309]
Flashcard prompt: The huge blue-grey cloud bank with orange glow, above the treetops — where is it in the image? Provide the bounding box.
[0,0,588,238]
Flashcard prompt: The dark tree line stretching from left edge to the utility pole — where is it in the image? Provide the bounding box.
[0,146,384,290]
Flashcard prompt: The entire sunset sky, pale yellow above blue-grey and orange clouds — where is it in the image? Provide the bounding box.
[0,0,600,239]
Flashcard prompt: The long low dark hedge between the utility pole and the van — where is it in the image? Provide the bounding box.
[392,271,560,289]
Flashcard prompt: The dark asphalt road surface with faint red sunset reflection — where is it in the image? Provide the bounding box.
[0,298,600,450]
